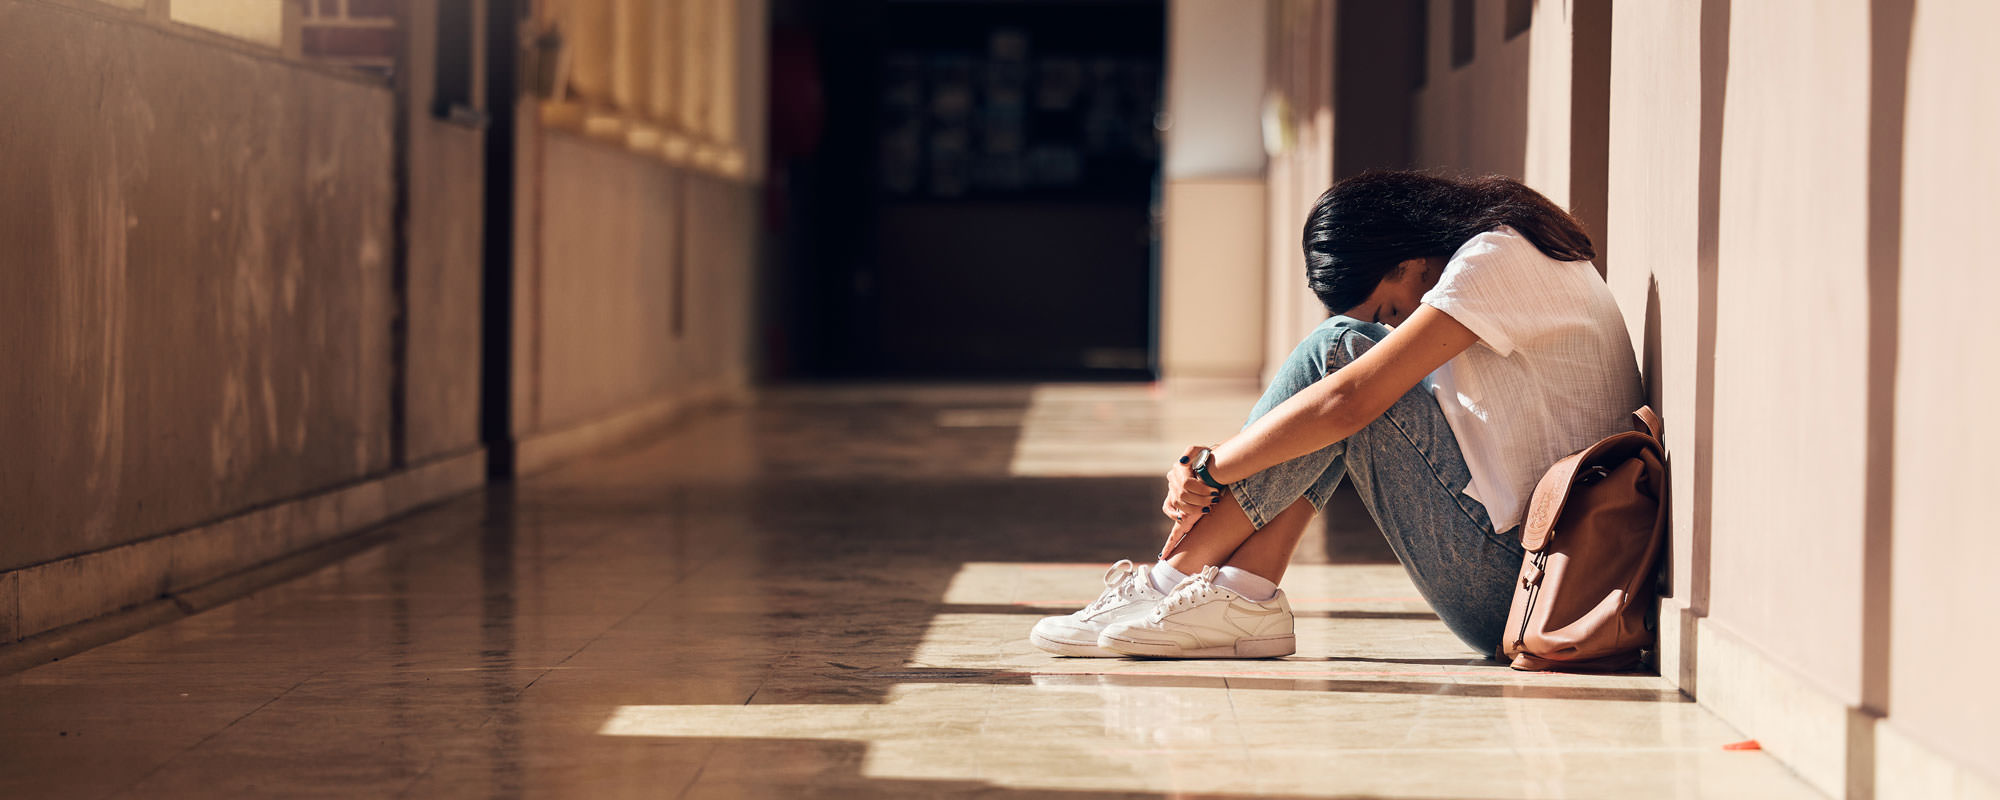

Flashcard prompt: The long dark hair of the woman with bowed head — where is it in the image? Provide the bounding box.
[1306,172,1598,314]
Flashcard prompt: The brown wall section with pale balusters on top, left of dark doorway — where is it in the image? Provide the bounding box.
[512,0,768,472]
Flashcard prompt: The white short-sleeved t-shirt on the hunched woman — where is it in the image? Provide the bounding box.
[1424,226,1644,532]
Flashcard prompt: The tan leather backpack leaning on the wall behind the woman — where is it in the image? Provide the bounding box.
[1500,406,1666,672]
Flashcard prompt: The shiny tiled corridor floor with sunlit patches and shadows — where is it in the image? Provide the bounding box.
[0,386,1812,798]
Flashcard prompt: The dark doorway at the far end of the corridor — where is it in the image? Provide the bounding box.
[766,0,1166,378]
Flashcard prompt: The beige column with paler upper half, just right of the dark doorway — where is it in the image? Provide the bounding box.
[1160,0,1266,382]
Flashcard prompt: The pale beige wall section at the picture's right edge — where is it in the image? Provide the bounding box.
[1870,2,2000,798]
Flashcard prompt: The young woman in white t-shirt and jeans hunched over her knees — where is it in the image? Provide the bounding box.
[1030,172,1644,658]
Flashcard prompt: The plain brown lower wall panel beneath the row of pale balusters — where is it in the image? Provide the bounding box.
[514,132,756,472]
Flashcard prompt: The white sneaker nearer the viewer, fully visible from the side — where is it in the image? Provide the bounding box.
[1098,566,1298,658]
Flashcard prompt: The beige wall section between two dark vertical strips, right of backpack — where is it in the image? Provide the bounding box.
[1700,0,1870,794]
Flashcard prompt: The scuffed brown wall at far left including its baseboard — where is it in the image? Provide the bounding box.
[0,0,484,644]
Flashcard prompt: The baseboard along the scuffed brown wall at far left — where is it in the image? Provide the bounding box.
[0,448,486,660]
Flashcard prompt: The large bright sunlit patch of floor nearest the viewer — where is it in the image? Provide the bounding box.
[598,674,1810,798]
